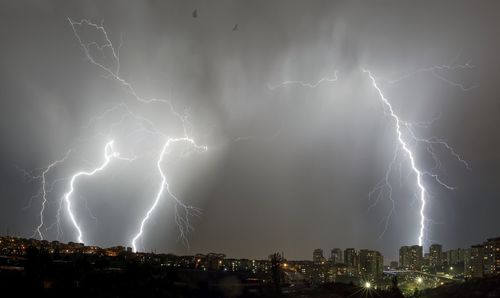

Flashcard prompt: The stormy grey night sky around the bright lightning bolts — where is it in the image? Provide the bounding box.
[0,0,500,259]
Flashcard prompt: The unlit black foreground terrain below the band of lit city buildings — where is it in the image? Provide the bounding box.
[0,250,500,298]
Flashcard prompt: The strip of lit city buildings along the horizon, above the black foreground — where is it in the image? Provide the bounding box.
[0,236,500,276]
